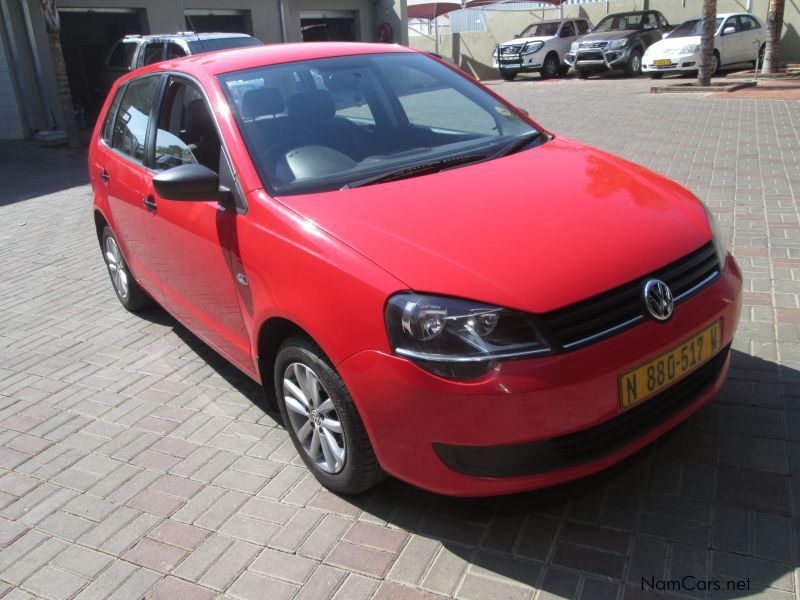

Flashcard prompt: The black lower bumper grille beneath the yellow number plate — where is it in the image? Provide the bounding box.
[552,346,730,464]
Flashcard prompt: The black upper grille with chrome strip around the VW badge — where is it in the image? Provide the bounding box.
[540,242,720,350]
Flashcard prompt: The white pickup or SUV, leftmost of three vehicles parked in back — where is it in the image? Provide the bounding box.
[494,19,592,81]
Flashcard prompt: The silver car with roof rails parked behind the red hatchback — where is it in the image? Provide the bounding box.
[103,31,261,90]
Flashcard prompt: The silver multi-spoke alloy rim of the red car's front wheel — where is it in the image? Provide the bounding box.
[283,362,347,474]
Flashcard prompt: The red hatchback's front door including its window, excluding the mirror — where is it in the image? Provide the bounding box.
[139,77,252,366]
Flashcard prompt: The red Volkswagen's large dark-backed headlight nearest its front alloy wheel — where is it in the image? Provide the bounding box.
[385,292,550,379]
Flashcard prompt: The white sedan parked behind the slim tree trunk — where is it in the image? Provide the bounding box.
[642,13,766,78]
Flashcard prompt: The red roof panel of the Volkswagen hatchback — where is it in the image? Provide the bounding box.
[134,42,412,76]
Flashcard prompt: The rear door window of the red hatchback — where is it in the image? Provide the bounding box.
[111,76,161,162]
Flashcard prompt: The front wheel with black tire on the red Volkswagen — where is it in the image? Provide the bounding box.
[274,335,384,494]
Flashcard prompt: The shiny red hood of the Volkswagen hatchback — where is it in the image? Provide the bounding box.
[279,138,711,313]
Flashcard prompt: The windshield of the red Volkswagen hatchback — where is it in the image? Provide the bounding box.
[219,52,536,195]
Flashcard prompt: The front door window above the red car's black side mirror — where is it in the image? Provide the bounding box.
[155,78,220,171]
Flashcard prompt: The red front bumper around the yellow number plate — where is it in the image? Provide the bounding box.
[338,257,742,496]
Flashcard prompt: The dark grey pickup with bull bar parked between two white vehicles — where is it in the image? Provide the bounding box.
[566,10,672,78]
